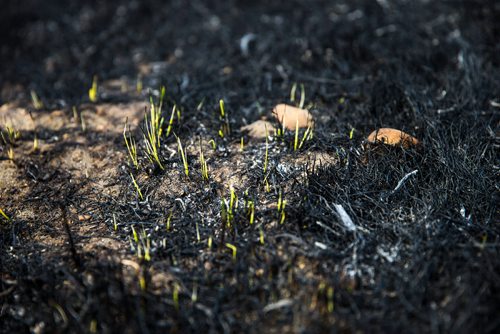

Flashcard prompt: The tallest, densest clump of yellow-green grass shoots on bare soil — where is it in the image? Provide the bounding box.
[143,87,165,170]
